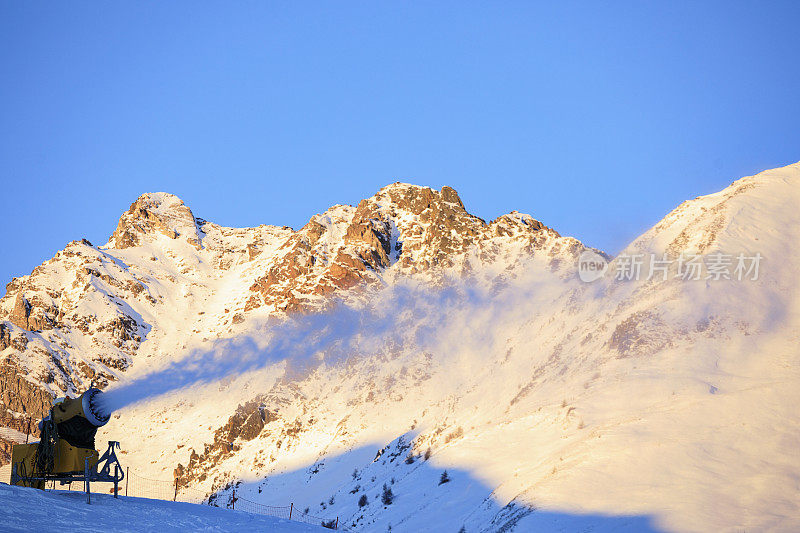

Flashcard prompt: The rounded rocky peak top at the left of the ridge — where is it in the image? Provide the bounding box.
[108,192,200,249]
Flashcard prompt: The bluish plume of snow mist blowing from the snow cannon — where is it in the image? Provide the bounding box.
[97,268,576,412]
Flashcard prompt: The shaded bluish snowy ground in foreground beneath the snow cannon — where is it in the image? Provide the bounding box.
[0,484,327,533]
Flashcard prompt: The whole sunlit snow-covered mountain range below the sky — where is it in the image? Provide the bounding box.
[0,164,800,531]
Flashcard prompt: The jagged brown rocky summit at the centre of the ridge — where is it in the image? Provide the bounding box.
[241,183,584,312]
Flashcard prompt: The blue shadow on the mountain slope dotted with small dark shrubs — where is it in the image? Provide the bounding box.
[209,434,660,533]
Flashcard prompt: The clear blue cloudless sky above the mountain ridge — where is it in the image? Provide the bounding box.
[0,0,800,284]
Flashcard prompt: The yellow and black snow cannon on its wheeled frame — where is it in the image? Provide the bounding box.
[11,387,124,496]
